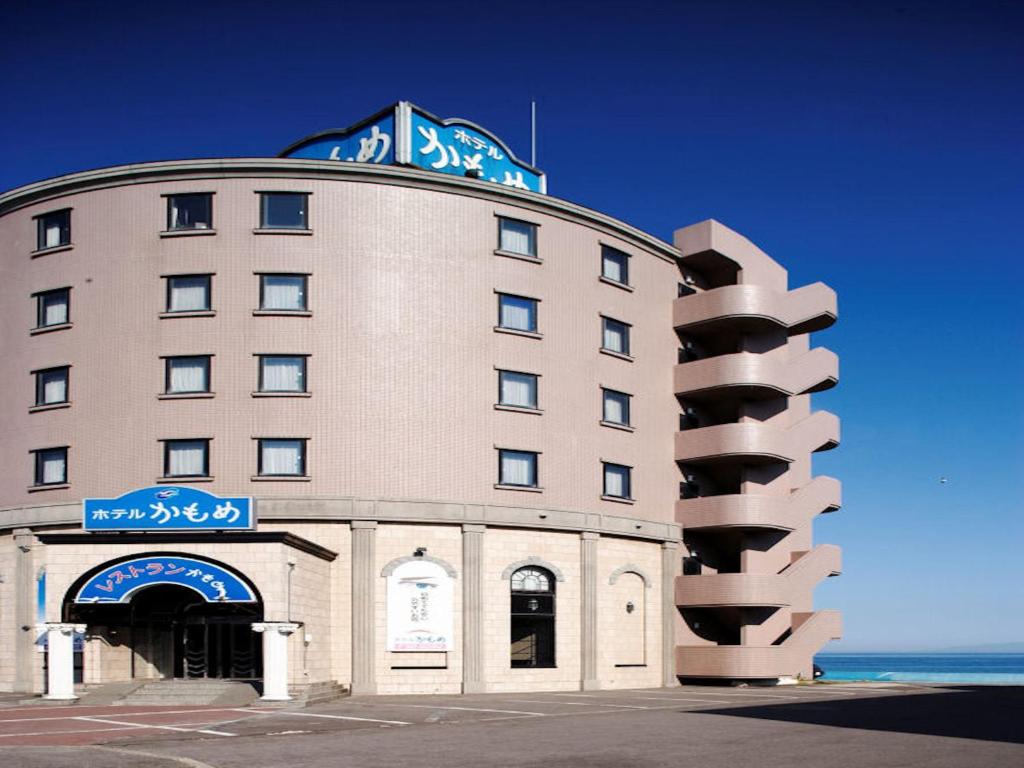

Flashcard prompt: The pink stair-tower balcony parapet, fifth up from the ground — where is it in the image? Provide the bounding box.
[674,347,839,401]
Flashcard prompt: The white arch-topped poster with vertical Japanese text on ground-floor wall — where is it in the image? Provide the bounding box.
[387,558,453,651]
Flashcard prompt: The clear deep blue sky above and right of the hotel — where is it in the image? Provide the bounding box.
[0,0,1024,649]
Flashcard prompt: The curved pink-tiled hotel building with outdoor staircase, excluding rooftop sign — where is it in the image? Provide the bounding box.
[0,105,840,698]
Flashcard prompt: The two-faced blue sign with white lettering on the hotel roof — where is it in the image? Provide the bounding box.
[281,101,548,195]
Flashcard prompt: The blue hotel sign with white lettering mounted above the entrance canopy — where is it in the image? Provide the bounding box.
[82,485,255,530]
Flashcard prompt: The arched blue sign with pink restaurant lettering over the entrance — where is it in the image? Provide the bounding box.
[75,555,257,603]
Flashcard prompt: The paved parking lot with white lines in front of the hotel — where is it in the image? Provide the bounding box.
[0,684,1024,768]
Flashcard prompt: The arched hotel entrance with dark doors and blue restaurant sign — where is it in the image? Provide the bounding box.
[65,553,263,681]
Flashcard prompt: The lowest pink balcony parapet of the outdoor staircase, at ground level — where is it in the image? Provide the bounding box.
[676,610,843,680]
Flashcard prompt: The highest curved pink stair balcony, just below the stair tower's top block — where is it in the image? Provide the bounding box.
[672,283,837,336]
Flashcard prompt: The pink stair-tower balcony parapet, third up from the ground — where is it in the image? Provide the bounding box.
[676,475,842,530]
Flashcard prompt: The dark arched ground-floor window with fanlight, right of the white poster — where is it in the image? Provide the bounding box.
[510,565,555,667]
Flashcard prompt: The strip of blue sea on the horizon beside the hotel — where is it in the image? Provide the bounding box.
[814,653,1024,685]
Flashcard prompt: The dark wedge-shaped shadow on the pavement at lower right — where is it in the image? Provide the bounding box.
[699,686,1024,743]
